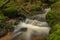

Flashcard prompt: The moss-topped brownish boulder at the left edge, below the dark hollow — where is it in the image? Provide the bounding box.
[0,13,10,37]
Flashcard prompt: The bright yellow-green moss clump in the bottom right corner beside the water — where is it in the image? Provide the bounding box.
[47,23,60,40]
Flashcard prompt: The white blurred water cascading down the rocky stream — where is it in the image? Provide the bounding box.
[12,8,50,40]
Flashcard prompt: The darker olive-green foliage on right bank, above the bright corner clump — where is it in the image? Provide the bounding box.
[46,1,60,26]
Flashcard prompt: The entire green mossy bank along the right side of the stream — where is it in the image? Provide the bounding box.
[46,0,60,40]
